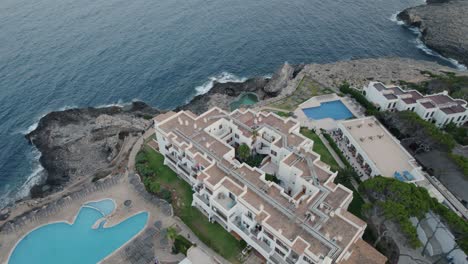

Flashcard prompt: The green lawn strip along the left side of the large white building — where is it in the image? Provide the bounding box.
[137,146,245,263]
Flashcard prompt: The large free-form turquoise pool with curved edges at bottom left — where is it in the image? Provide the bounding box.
[9,200,148,264]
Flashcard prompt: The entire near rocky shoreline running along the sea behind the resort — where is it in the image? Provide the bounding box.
[0,58,465,223]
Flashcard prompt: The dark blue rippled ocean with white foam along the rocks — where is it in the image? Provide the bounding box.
[0,0,462,207]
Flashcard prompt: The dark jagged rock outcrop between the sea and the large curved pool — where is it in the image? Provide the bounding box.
[26,102,159,197]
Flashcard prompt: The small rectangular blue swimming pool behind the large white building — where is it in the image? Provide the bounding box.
[302,100,354,120]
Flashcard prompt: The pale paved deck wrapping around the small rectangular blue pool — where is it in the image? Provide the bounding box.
[294,93,364,130]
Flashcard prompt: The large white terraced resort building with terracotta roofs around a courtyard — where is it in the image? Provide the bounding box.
[155,108,386,264]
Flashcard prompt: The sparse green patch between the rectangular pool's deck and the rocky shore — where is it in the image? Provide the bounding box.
[271,76,333,111]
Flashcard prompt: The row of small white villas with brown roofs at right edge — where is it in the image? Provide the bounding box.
[364,82,468,127]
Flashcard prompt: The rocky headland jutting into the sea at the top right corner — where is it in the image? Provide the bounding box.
[398,0,468,65]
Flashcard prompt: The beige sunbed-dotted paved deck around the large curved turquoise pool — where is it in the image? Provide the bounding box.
[0,129,228,264]
